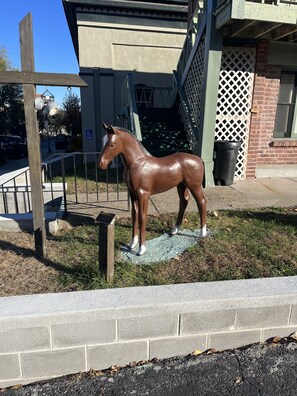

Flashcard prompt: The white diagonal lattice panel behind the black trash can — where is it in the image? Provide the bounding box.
[215,47,255,179]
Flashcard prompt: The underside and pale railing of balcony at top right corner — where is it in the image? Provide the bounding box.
[215,0,297,43]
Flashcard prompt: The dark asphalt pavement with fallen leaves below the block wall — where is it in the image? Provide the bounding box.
[0,337,297,396]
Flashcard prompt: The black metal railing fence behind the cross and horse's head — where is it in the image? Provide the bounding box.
[0,152,129,215]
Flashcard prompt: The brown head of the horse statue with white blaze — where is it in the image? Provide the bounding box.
[98,123,122,169]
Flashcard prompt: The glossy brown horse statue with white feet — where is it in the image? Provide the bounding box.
[98,124,206,256]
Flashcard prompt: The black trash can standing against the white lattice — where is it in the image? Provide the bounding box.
[213,140,241,186]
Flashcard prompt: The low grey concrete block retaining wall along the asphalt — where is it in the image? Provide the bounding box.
[0,277,297,388]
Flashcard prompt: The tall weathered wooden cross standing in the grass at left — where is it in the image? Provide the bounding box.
[0,13,87,257]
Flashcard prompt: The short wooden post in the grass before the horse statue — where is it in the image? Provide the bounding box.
[96,212,116,282]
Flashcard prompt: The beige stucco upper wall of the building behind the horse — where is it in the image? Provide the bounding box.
[78,24,185,73]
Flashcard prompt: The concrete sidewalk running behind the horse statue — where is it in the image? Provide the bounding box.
[68,177,297,219]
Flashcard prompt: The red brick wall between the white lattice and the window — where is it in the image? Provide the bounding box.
[246,41,297,178]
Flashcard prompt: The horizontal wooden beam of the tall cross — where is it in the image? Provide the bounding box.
[0,71,88,88]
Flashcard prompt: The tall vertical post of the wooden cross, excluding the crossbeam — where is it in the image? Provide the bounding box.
[19,14,46,257]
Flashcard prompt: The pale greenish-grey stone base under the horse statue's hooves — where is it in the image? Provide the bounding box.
[120,229,207,265]
